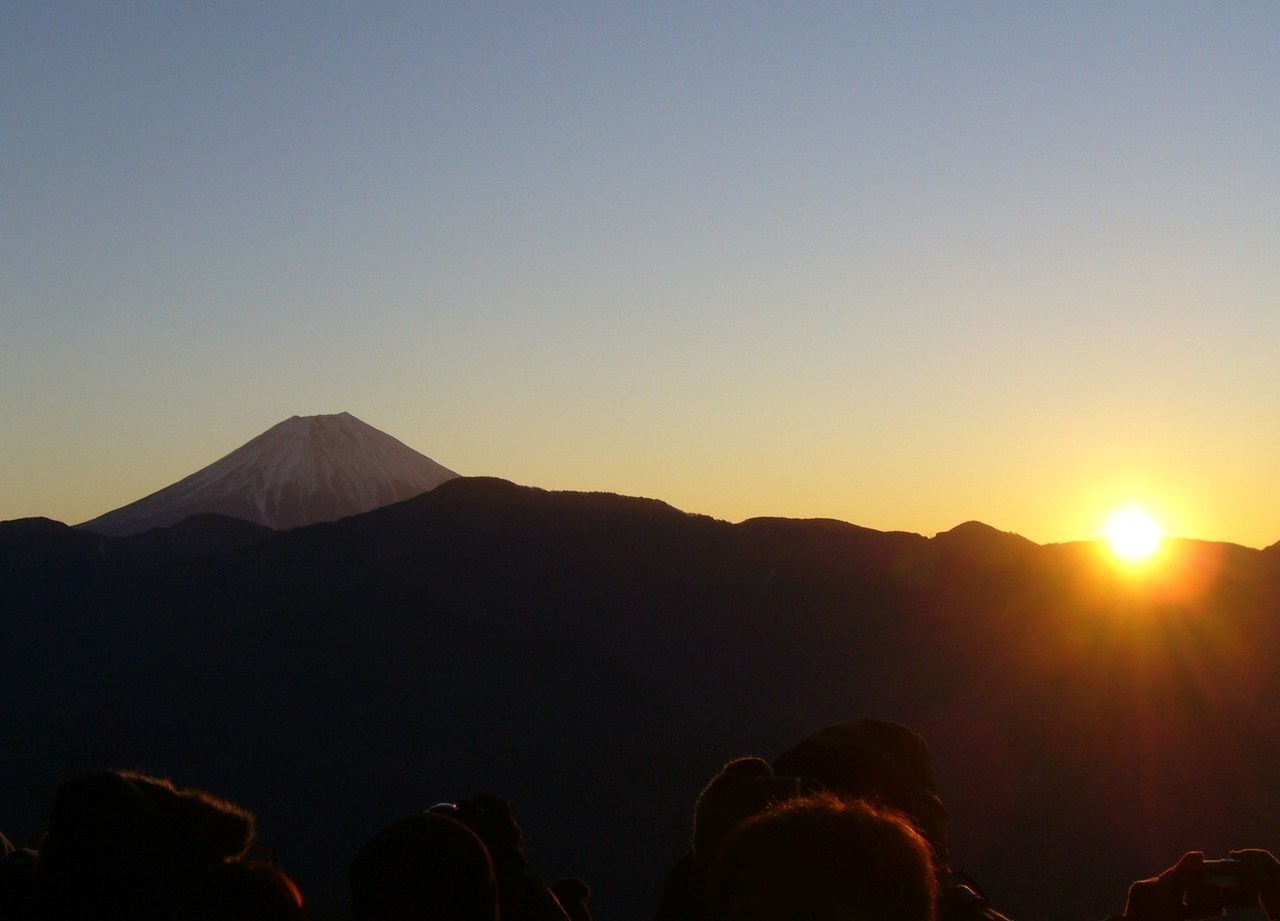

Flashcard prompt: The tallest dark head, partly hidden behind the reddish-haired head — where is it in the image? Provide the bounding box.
[773,719,950,869]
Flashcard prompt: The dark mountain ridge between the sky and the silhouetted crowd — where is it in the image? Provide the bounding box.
[0,478,1280,921]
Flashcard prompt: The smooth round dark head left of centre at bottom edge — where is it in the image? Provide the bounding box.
[349,812,498,921]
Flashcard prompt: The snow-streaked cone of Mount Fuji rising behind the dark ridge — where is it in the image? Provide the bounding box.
[78,412,458,536]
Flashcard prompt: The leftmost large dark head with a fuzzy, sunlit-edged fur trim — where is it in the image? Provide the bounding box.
[36,771,255,921]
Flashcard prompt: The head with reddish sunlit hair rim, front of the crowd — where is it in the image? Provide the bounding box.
[710,794,937,921]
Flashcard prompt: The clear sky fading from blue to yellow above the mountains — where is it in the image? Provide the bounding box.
[0,0,1280,547]
